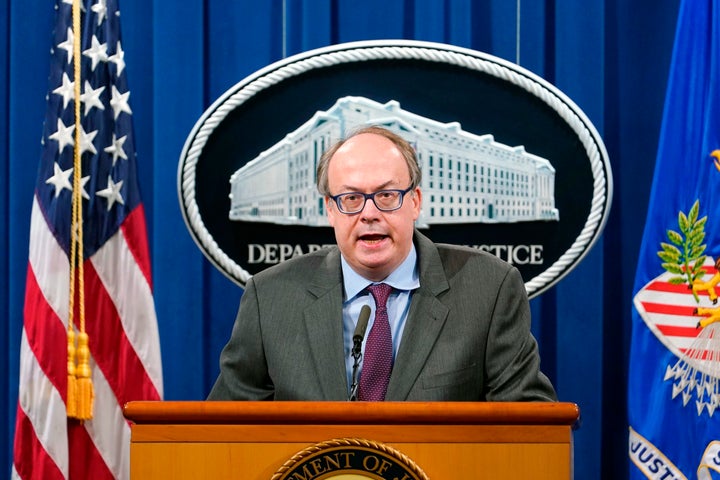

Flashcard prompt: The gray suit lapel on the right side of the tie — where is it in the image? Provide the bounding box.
[385,231,449,401]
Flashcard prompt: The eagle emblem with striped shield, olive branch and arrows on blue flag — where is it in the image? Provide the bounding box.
[634,200,720,417]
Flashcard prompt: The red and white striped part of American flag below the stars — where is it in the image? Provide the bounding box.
[13,199,163,479]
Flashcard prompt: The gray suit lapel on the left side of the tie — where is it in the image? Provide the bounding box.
[303,250,348,400]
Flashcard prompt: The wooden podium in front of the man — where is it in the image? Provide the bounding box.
[125,401,579,480]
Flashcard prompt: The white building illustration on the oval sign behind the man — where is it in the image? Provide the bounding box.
[229,96,560,228]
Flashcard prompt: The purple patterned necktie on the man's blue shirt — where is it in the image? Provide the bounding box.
[358,283,393,402]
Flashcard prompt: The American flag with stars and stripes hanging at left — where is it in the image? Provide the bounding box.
[12,0,163,479]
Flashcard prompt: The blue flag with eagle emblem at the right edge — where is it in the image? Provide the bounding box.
[628,0,720,480]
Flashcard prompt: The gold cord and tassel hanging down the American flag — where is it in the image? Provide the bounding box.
[67,0,95,420]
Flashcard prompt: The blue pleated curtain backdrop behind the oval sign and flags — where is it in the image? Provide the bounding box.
[0,0,678,479]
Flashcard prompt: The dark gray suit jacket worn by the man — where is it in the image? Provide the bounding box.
[208,232,556,401]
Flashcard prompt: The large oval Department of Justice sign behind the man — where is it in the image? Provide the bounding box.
[178,40,612,298]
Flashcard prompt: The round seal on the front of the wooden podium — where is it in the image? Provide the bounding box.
[271,438,428,480]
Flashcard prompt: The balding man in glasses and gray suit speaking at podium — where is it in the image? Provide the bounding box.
[208,127,556,401]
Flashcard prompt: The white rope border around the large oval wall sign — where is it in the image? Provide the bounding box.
[178,41,611,295]
